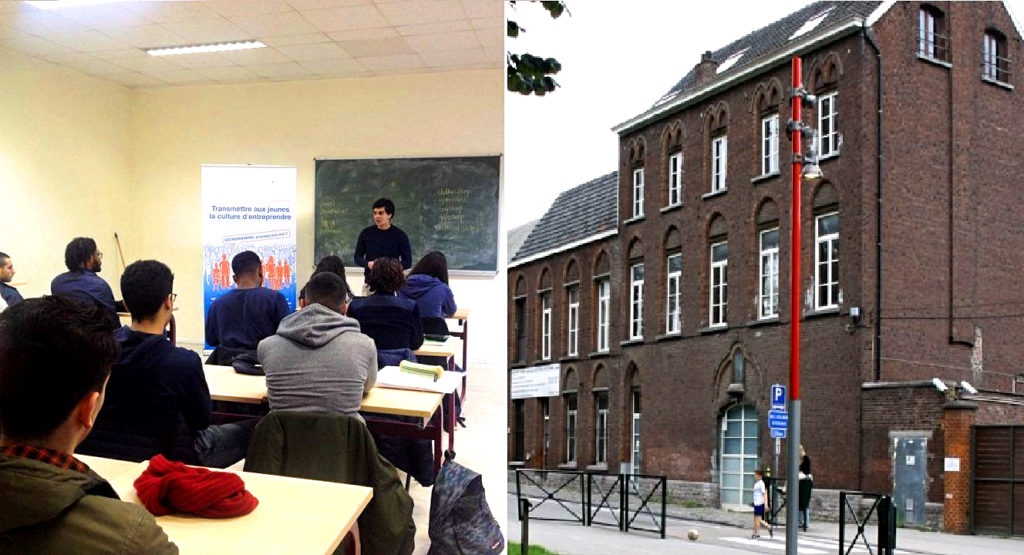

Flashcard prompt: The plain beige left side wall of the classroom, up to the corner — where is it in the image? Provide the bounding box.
[0,48,132,296]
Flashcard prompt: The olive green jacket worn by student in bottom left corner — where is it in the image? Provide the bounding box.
[0,455,178,554]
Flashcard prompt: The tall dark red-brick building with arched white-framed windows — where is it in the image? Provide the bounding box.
[508,2,1024,533]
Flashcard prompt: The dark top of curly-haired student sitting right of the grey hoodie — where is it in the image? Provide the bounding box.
[348,293,423,350]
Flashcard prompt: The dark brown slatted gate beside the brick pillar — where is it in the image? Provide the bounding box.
[971,426,1024,536]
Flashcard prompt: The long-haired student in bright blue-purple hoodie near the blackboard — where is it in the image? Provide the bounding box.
[398,251,458,335]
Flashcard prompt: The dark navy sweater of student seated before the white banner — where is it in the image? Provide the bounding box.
[206,287,290,351]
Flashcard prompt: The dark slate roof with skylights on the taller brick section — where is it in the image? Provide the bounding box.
[622,1,883,132]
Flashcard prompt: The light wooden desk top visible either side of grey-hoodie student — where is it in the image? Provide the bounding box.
[204,365,443,419]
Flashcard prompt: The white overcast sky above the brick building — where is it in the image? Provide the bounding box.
[503,0,1024,229]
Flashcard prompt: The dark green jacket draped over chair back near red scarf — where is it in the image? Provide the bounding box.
[246,411,416,555]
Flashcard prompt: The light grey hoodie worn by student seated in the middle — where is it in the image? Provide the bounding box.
[256,304,377,420]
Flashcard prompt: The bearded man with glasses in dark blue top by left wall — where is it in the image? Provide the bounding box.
[50,237,121,330]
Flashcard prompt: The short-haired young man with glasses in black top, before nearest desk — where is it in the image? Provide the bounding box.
[82,260,256,468]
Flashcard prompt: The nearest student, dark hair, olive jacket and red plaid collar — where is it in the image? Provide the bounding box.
[0,297,178,554]
